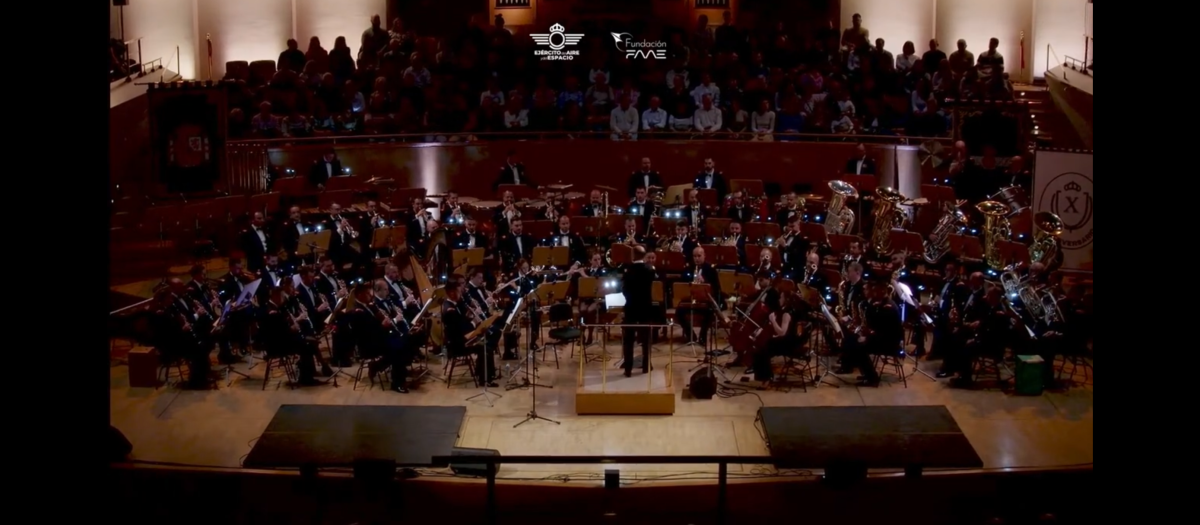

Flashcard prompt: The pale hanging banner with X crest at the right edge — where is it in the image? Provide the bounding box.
[1033,151,1094,272]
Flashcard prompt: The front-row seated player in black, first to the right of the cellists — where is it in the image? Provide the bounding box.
[842,278,904,386]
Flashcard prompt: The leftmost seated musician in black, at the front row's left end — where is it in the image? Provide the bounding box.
[150,289,211,390]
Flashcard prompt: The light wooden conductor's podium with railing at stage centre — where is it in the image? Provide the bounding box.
[575,318,676,416]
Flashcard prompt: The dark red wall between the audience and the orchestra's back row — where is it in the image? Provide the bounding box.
[262,140,926,197]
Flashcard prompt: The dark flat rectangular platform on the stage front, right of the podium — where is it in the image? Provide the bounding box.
[758,406,983,469]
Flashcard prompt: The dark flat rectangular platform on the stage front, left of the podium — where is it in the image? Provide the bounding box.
[244,405,467,469]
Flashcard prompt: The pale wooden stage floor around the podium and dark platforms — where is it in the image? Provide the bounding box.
[110,335,1093,483]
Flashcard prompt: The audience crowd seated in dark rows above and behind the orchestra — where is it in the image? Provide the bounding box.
[220,13,1013,141]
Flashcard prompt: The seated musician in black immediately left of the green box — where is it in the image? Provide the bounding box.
[938,286,1019,388]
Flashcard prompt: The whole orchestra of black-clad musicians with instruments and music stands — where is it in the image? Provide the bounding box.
[131,158,1090,392]
